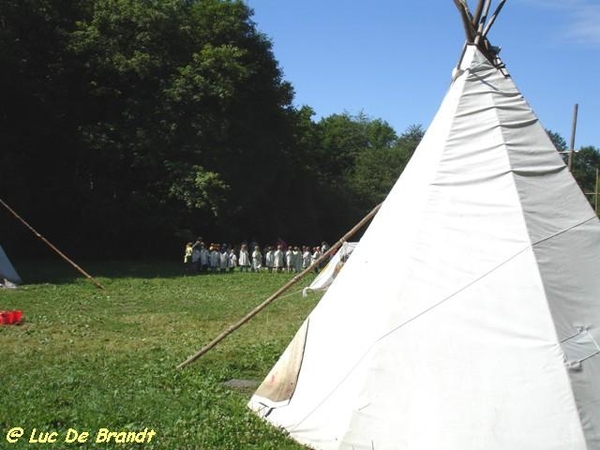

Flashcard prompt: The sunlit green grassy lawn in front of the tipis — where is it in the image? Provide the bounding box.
[0,261,324,450]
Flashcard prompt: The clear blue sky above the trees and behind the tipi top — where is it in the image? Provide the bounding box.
[246,0,600,149]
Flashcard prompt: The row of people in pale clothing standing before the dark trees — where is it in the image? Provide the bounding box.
[183,238,329,273]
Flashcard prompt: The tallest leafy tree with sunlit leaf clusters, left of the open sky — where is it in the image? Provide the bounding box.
[71,0,300,253]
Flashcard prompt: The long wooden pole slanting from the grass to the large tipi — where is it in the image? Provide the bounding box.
[177,204,381,369]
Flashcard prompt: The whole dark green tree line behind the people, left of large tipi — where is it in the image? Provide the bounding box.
[0,0,598,258]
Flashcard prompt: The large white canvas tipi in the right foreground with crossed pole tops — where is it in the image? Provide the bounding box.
[249,1,600,450]
